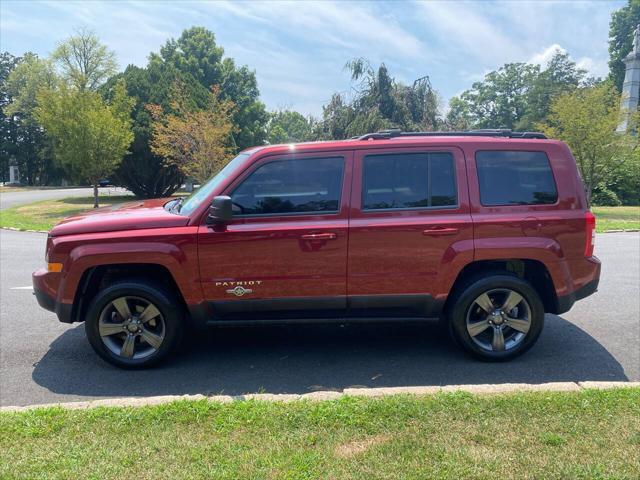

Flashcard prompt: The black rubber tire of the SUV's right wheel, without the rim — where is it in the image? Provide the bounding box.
[449,275,544,362]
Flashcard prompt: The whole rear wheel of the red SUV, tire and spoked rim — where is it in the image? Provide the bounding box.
[449,274,544,361]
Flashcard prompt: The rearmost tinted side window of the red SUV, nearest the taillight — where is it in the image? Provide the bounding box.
[476,151,558,205]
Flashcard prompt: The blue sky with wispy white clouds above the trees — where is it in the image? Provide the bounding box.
[0,0,626,116]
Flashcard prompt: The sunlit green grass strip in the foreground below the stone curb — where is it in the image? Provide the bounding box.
[0,388,640,480]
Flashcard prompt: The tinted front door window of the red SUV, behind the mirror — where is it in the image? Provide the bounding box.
[231,158,344,215]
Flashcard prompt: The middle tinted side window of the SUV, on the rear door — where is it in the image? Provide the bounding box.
[362,153,456,210]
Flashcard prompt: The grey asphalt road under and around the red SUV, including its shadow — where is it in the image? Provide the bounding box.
[0,230,640,405]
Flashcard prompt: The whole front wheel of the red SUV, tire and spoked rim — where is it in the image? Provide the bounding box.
[85,280,183,369]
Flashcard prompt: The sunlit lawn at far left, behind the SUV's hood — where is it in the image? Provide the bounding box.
[0,195,135,230]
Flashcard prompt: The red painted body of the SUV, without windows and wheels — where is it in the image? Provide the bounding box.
[33,136,600,323]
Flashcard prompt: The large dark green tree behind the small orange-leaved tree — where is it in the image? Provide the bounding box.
[107,27,268,198]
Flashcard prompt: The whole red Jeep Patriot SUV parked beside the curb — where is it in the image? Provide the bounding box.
[33,130,600,368]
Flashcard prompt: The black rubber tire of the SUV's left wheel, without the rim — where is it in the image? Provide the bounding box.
[85,280,183,369]
